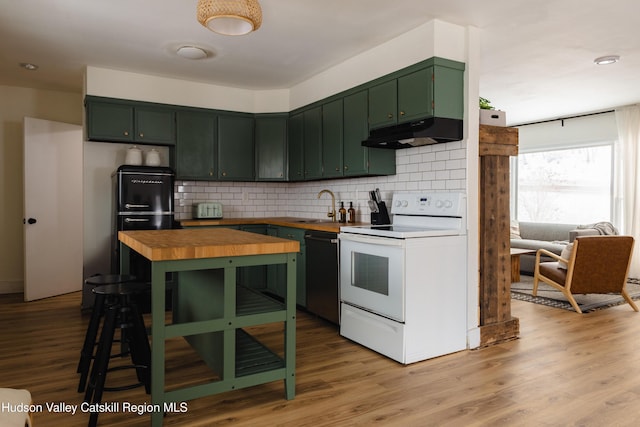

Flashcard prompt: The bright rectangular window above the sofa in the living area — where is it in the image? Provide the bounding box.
[516,144,613,224]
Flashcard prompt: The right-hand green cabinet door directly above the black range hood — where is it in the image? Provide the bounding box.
[398,67,433,123]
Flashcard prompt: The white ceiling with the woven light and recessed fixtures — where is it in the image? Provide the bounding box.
[0,0,640,124]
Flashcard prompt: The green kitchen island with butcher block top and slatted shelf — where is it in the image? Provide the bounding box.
[118,228,299,426]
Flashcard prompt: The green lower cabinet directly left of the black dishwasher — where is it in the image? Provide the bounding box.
[267,225,307,307]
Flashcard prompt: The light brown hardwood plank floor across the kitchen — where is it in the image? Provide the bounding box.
[0,293,640,427]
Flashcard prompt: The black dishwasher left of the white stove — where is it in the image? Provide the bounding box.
[304,230,340,324]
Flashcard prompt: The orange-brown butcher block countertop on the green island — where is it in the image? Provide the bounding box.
[118,228,300,261]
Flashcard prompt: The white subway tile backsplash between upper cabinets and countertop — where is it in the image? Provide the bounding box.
[175,141,466,222]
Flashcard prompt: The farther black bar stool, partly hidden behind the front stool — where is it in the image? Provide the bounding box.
[76,274,136,393]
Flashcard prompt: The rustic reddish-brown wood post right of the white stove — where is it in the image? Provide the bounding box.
[479,125,520,346]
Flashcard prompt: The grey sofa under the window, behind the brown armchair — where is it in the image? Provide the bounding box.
[511,221,603,276]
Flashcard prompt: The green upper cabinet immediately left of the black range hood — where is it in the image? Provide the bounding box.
[343,89,396,176]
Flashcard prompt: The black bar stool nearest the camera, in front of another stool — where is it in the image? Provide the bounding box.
[84,283,151,426]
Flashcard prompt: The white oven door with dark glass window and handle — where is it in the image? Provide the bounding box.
[339,233,405,322]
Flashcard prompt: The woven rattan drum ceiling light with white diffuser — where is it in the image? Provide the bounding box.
[197,0,262,36]
